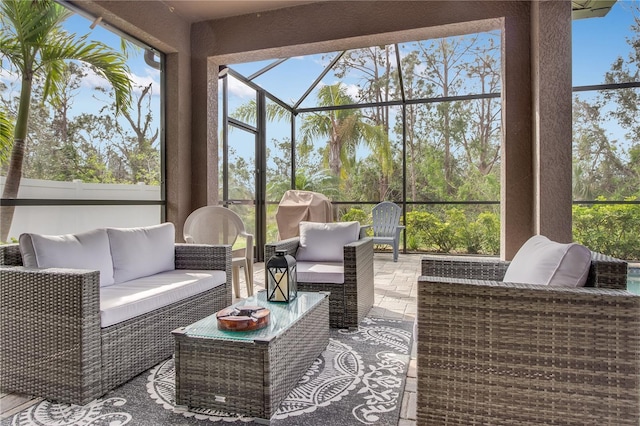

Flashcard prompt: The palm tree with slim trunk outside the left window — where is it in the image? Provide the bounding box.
[0,0,131,241]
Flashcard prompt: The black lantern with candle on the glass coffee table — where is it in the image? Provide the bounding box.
[267,250,298,302]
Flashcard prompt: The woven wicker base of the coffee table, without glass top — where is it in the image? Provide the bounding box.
[174,292,329,420]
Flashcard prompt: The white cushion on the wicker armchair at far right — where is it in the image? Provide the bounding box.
[504,235,591,287]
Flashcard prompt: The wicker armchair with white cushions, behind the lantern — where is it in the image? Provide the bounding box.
[264,222,374,328]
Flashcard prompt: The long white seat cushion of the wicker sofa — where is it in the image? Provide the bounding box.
[100,269,227,327]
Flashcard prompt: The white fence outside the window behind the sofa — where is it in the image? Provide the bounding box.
[0,176,162,240]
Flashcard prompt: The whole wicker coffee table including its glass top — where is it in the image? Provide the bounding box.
[173,291,329,423]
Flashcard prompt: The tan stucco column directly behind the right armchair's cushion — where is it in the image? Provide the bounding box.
[531,0,572,242]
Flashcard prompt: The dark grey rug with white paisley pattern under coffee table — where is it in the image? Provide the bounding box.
[2,318,413,426]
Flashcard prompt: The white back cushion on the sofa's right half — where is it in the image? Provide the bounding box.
[107,222,175,283]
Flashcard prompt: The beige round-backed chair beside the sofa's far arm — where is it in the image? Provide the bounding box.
[183,206,253,297]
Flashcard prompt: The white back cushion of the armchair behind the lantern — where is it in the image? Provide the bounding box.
[296,221,360,262]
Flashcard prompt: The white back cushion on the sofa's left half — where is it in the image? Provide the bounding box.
[18,229,113,286]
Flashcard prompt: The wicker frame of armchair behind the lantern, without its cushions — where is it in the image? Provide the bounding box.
[264,237,374,328]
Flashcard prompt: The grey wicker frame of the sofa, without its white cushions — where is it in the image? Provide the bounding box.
[0,244,231,404]
